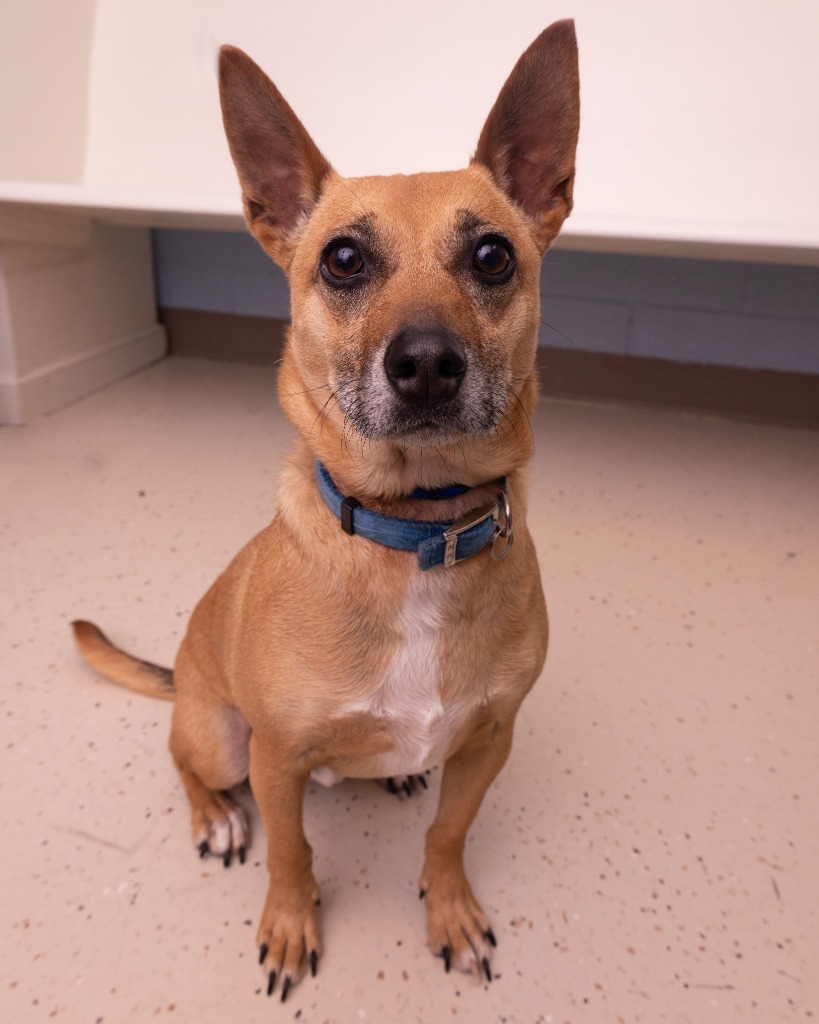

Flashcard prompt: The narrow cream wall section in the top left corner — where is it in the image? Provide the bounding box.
[0,0,95,181]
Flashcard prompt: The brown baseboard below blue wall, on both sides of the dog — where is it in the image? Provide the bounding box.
[160,308,819,427]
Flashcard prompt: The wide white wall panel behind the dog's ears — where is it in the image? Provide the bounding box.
[86,0,819,245]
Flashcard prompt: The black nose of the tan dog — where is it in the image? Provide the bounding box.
[384,328,467,407]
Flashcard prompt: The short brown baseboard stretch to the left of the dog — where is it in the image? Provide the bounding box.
[159,306,288,366]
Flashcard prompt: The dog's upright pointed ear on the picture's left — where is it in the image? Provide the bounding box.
[219,46,333,269]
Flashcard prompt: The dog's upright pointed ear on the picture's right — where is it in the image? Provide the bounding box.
[473,20,580,252]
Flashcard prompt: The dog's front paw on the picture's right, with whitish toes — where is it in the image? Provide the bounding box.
[421,876,498,981]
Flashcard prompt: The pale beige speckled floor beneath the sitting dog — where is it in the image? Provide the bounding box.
[0,359,819,1024]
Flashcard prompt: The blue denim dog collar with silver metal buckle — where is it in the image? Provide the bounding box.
[314,459,513,570]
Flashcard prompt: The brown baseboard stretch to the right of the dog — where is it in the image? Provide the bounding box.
[537,347,819,427]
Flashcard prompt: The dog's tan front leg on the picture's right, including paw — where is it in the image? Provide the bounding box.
[420,718,514,981]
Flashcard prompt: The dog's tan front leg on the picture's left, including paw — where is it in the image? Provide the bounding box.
[250,732,321,1002]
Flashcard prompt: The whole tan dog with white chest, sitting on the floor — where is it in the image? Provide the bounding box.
[75,22,578,998]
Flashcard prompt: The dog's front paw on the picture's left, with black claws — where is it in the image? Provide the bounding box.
[256,882,321,1002]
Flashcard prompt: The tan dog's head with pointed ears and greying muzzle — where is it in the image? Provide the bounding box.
[220,22,578,493]
